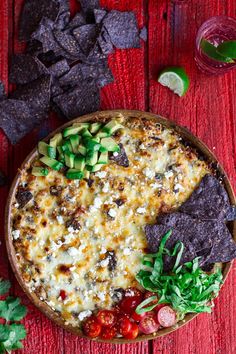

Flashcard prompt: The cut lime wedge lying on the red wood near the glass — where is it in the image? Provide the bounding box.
[158,66,189,97]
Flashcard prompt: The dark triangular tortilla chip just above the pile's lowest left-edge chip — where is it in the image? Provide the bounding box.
[10,75,51,112]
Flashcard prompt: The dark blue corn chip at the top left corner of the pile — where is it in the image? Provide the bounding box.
[19,0,60,41]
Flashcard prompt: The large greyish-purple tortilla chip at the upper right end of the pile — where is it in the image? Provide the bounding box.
[103,10,140,49]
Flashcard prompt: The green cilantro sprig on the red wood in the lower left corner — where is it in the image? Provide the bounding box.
[0,279,26,353]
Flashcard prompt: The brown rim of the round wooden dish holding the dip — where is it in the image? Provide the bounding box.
[5,110,236,343]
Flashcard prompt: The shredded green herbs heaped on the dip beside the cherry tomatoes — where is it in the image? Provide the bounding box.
[136,230,223,318]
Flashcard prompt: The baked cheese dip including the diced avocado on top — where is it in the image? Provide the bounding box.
[11,115,210,332]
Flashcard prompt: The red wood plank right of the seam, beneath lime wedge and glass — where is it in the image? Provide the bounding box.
[149,0,236,354]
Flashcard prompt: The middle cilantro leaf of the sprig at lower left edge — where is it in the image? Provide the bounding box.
[0,296,26,321]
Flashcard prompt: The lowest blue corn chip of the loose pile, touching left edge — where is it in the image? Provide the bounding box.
[0,99,47,144]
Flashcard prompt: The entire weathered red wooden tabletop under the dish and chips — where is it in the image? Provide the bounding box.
[0,0,236,354]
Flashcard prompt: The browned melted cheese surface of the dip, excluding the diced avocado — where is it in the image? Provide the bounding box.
[12,119,209,326]
